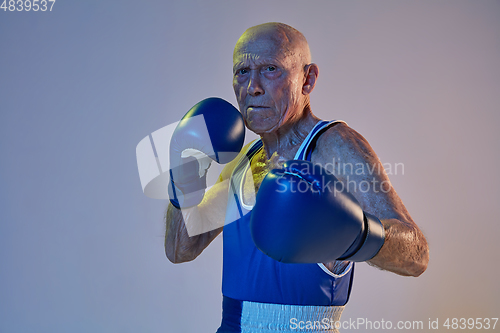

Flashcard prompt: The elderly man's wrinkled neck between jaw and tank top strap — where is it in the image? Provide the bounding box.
[261,111,320,160]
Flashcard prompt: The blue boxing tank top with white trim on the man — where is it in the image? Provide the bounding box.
[222,121,354,306]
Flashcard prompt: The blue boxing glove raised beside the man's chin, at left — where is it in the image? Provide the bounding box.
[168,97,245,208]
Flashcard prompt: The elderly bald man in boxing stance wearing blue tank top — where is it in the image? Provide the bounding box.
[165,23,429,333]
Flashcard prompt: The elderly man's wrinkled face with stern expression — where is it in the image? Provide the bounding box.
[233,36,304,134]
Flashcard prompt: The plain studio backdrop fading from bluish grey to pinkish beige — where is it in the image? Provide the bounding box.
[0,0,500,333]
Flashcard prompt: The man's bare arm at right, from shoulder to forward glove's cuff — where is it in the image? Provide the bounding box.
[312,124,429,276]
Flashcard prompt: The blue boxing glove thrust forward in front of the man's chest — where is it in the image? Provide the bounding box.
[250,160,385,263]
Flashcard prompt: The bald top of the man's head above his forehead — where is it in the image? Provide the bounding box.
[233,22,311,67]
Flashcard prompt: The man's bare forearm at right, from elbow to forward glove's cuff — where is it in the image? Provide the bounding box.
[368,219,429,277]
